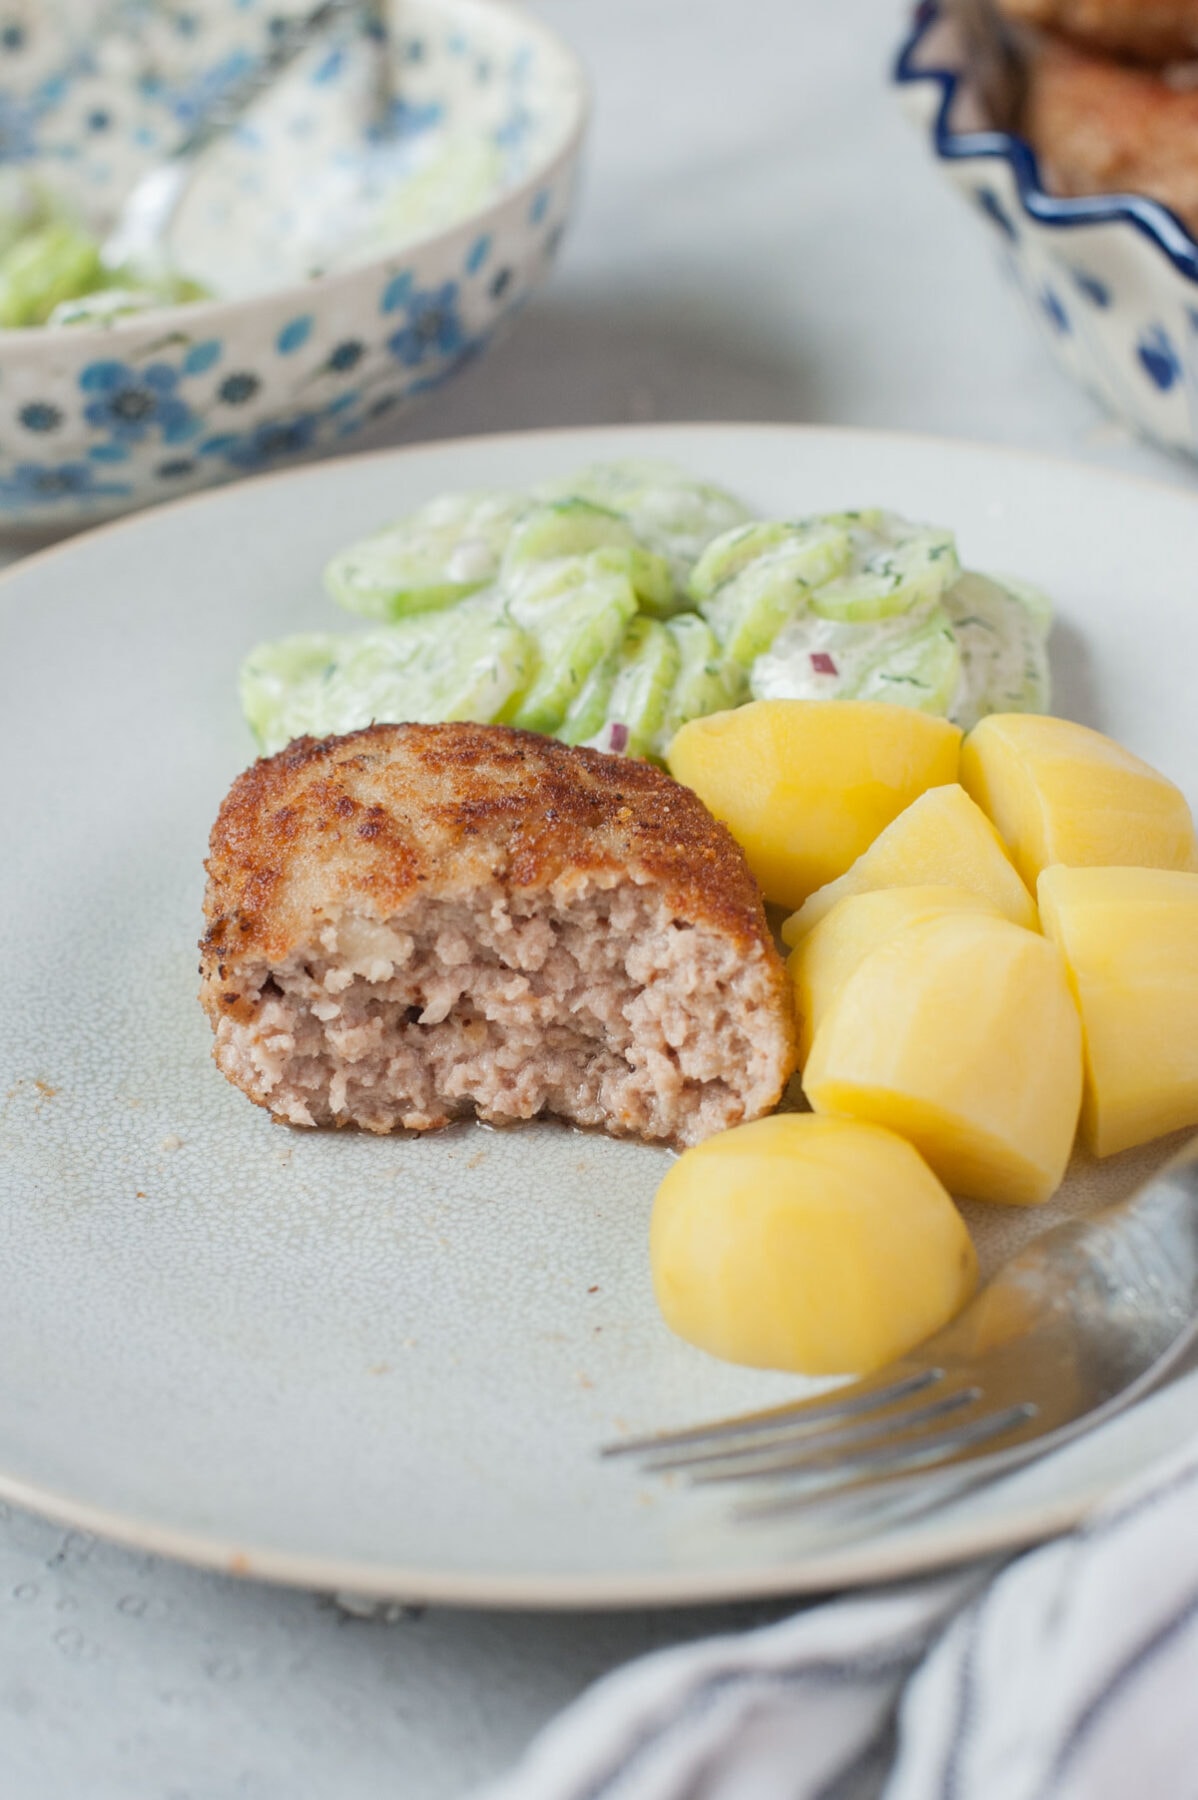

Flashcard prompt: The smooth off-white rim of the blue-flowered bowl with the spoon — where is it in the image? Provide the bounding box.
[0,0,586,360]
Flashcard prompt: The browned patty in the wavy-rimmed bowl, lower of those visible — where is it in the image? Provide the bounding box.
[1024,40,1198,230]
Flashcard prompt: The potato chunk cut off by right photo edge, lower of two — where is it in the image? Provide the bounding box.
[1040,868,1198,1156]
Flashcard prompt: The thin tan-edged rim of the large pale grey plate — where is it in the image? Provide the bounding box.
[0,419,1193,1611]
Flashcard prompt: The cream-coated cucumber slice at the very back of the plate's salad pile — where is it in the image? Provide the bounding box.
[536,457,752,612]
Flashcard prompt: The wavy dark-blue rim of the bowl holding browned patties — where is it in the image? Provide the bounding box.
[892,0,1198,283]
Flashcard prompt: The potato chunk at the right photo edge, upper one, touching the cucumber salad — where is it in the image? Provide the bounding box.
[961,713,1198,889]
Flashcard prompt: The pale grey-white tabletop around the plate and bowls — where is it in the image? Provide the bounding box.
[0,0,1194,1800]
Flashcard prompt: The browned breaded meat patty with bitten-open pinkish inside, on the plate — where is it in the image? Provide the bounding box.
[201,724,793,1145]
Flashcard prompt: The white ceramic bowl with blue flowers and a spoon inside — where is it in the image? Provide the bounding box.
[0,0,586,531]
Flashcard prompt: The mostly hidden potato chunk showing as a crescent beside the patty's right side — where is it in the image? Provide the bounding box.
[782,889,1004,1067]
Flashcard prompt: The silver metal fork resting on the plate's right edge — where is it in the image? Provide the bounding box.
[603,1138,1198,1532]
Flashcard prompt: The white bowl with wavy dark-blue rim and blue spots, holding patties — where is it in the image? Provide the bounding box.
[894,0,1198,455]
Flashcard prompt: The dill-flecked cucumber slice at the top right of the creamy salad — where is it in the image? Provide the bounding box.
[811,509,961,625]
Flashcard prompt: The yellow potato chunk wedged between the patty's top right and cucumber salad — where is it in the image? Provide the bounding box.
[666,700,961,907]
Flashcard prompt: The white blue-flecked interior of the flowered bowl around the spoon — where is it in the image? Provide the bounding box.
[0,0,579,297]
